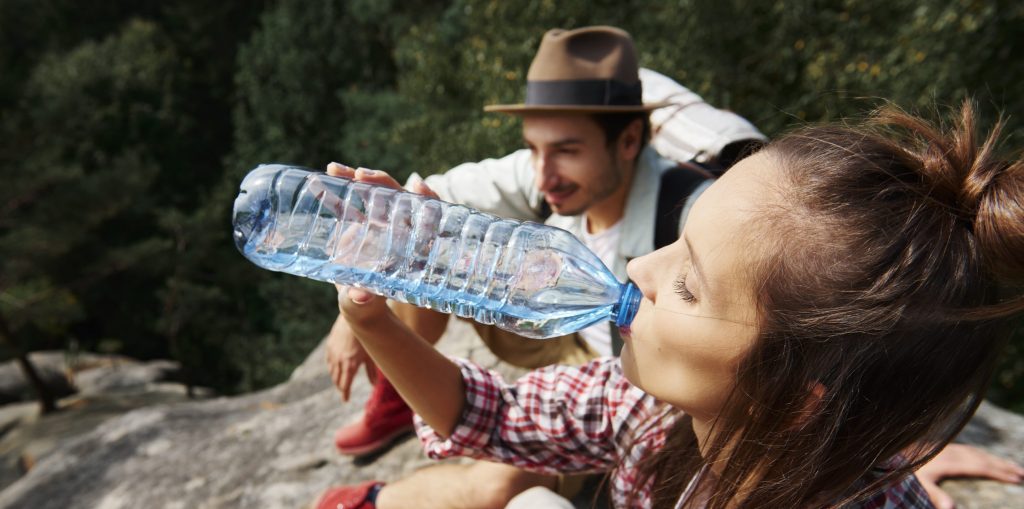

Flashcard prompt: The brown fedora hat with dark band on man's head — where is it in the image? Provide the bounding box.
[483,27,671,114]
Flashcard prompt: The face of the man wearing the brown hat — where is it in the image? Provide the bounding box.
[522,114,627,216]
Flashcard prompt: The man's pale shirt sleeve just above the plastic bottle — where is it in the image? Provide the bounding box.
[406,150,543,221]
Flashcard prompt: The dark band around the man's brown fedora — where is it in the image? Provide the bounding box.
[526,80,643,107]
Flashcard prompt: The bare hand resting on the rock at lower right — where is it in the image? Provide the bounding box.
[914,443,1024,509]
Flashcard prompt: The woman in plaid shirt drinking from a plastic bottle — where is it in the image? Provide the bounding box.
[331,103,1024,508]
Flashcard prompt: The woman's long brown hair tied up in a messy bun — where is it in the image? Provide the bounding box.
[633,101,1024,508]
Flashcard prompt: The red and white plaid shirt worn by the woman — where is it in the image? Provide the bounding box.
[417,357,932,509]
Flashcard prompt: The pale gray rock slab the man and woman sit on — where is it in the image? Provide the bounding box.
[0,323,1024,509]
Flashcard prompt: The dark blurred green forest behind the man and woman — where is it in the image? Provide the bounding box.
[0,0,1024,412]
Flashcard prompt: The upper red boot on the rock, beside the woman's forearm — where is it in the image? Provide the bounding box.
[334,369,413,456]
